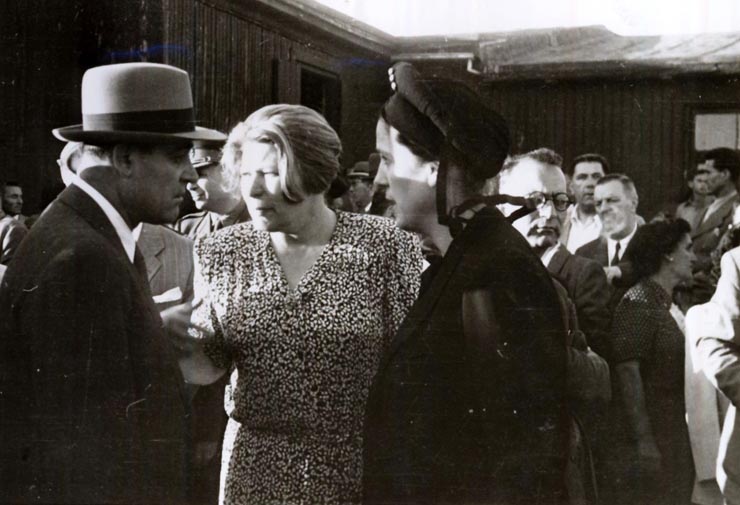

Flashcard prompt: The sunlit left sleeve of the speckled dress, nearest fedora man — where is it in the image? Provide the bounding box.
[190,239,232,370]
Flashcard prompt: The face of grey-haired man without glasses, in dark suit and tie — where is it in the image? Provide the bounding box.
[594,181,637,240]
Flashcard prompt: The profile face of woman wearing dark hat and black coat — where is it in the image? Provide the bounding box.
[375,119,437,233]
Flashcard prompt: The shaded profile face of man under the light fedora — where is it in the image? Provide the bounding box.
[129,144,197,224]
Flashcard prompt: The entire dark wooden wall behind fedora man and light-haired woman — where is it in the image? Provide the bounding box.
[0,0,390,214]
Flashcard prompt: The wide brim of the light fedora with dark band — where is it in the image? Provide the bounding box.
[52,124,226,144]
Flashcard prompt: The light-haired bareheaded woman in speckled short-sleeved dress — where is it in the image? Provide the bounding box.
[170,105,421,504]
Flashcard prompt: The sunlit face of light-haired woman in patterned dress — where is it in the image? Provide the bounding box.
[239,140,298,231]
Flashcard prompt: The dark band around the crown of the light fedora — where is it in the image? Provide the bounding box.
[82,108,195,133]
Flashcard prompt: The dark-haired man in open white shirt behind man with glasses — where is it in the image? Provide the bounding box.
[560,153,609,253]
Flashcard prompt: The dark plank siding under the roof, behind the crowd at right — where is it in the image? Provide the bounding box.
[478,77,740,217]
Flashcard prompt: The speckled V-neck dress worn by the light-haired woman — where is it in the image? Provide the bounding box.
[193,212,422,505]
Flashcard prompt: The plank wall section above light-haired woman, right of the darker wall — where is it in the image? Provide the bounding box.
[162,0,390,166]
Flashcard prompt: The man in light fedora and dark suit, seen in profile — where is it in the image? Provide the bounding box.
[0,63,223,503]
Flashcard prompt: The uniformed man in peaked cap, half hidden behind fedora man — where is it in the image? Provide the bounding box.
[175,141,249,240]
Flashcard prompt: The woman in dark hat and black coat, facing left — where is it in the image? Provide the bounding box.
[364,63,568,504]
